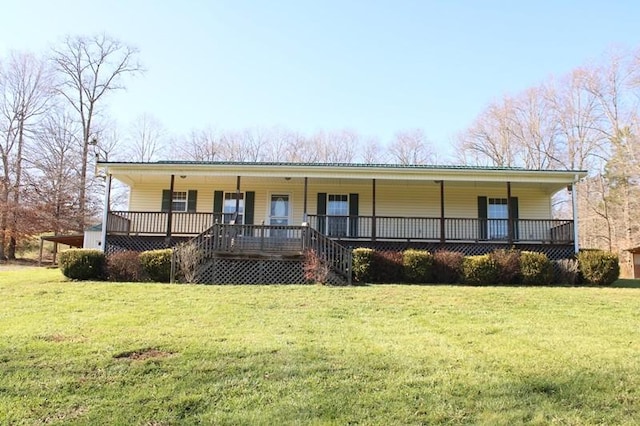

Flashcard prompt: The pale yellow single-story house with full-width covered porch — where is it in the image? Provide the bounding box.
[98,161,586,281]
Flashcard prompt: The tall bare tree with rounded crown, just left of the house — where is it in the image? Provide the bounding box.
[53,34,142,229]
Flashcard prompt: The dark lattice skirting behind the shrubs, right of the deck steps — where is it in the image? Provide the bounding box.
[340,240,574,260]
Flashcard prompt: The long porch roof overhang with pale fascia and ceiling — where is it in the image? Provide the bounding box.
[98,162,587,192]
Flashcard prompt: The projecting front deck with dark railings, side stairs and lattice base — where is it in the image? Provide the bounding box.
[172,223,351,284]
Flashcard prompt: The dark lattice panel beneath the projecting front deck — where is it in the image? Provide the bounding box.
[197,257,306,284]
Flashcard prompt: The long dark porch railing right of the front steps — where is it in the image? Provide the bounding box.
[308,215,574,244]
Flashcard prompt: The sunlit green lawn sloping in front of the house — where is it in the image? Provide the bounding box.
[0,267,640,425]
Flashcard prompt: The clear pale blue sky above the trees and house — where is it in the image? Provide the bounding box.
[0,0,640,156]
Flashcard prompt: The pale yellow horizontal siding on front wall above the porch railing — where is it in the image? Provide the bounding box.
[129,177,551,224]
